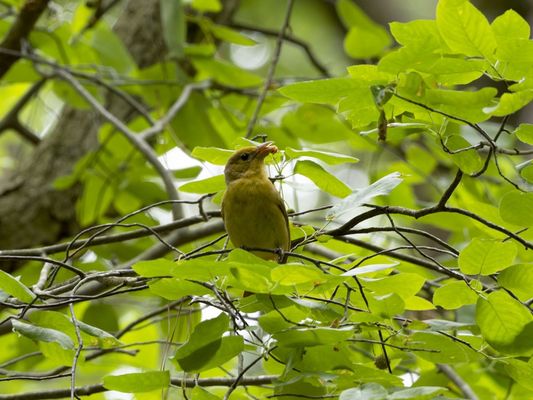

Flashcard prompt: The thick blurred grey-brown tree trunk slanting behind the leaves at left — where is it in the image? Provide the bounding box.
[0,0,165,253]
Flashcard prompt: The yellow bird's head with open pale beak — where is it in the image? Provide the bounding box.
[224,142,278,184]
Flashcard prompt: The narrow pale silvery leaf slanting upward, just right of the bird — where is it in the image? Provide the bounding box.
[326,172,403,220]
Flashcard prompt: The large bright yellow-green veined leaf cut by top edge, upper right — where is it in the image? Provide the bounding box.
[436,0,496,60]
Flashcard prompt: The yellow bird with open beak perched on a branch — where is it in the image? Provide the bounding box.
[222,142,290,261]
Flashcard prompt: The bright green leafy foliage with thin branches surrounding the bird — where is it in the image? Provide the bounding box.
[0,0,533,400]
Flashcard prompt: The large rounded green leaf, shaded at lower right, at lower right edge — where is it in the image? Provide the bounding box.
[476,290,533,354]
